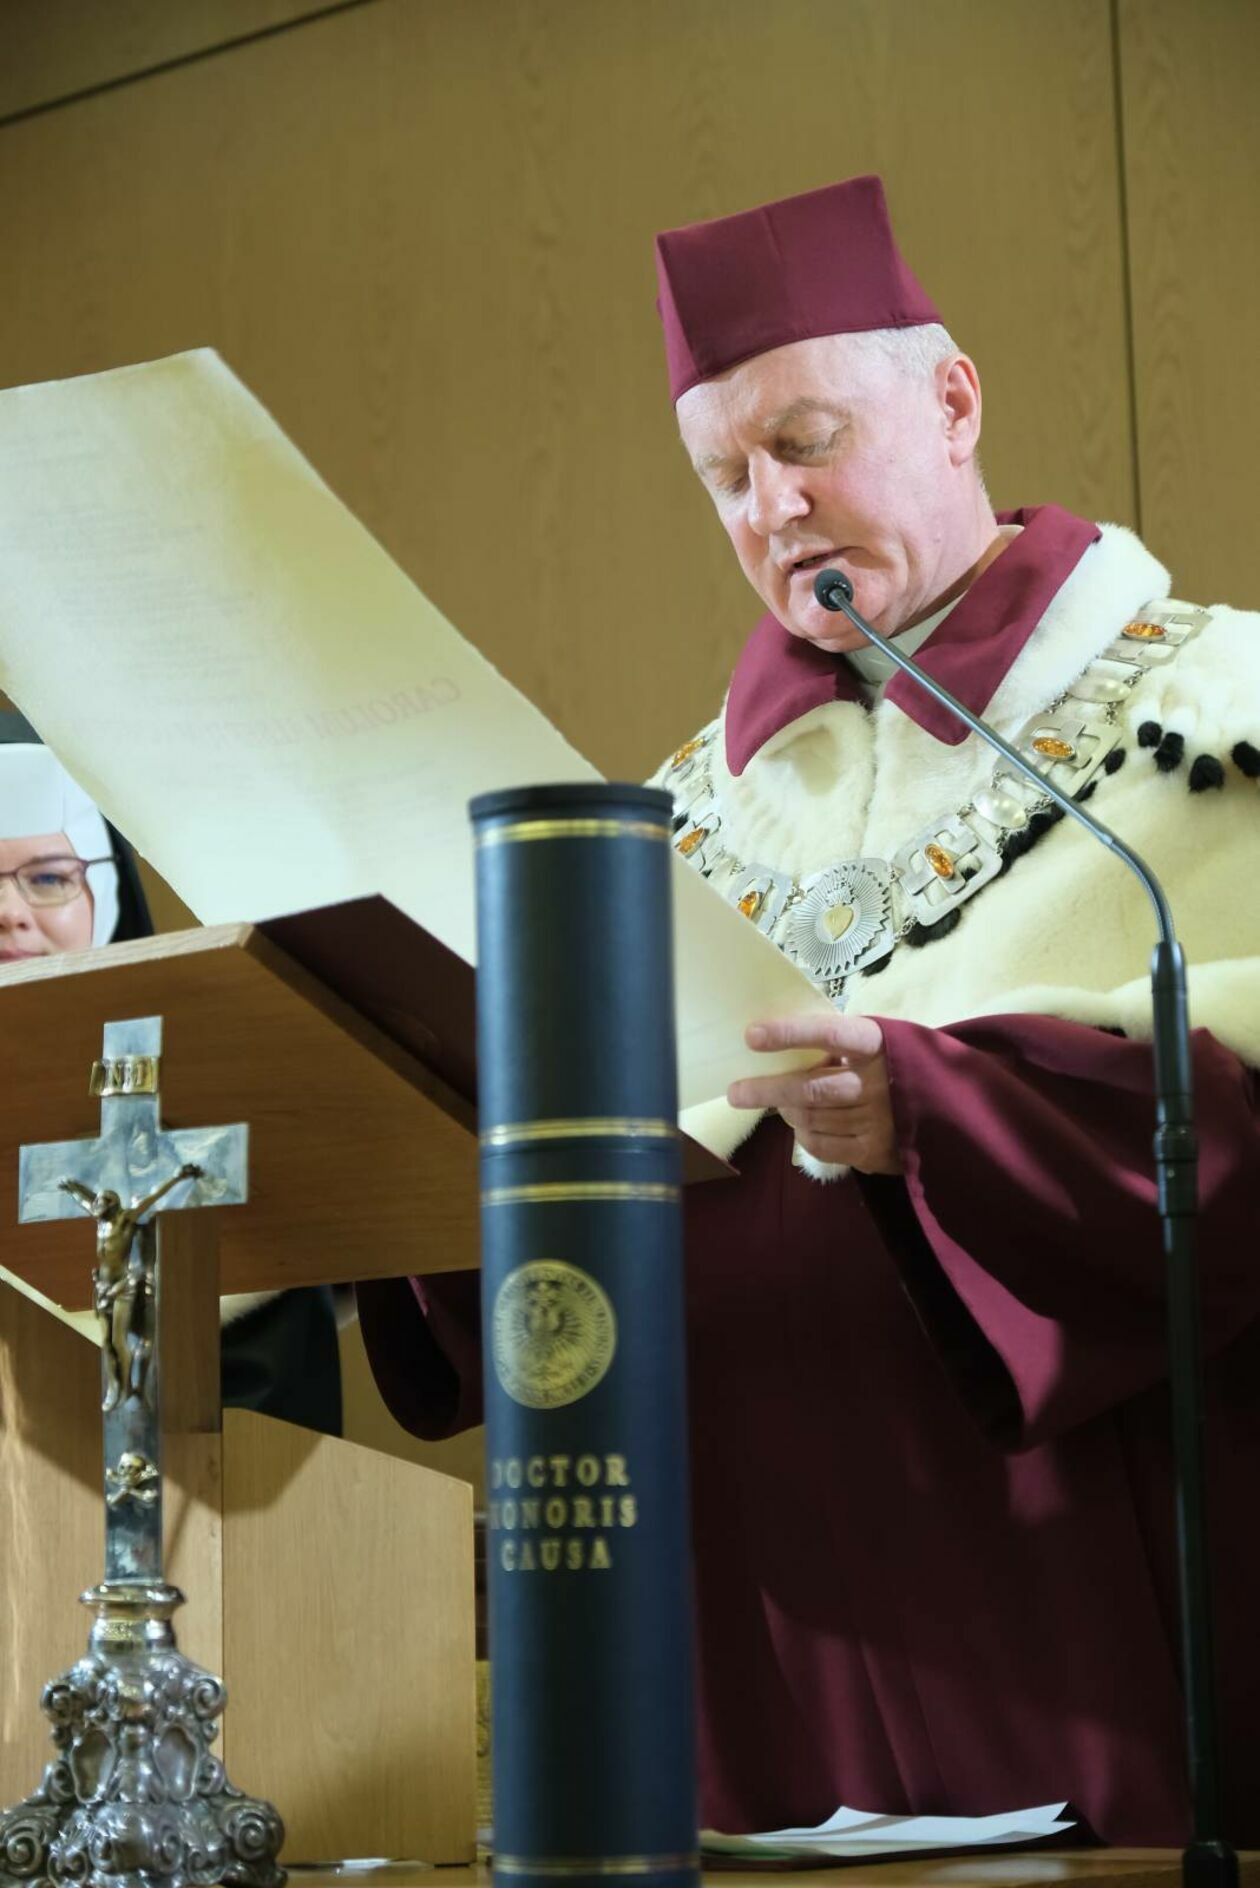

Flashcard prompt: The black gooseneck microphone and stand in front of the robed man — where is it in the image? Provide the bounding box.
[814,570,1237,1888]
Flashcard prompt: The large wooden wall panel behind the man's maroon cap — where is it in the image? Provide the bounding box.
[0,0,1132,796]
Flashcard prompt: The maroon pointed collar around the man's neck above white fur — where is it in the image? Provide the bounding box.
[725,504,1099,774]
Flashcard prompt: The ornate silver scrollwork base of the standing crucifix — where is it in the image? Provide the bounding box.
[0,1580,285,1888]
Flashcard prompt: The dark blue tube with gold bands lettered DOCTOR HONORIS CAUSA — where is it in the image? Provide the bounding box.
[470,785,699,1888]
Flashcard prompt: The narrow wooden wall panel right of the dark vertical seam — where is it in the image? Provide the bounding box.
[1120,0,1260,608]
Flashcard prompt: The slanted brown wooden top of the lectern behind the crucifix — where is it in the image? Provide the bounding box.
[0,899,478,1308]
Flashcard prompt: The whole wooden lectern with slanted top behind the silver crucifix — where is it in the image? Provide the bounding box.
[0,899,478,1863]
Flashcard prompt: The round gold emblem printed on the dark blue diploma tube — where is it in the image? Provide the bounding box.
[491,1259,618,1410]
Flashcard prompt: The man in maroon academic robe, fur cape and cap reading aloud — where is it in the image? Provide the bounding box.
[361,177,1260,1845]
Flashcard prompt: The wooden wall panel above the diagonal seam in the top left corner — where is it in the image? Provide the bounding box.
[0,0,358,119]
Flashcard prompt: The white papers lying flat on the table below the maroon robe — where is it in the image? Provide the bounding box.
[701,1803,1075,1862]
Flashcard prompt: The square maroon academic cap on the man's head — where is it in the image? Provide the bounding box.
[656,177,941,400]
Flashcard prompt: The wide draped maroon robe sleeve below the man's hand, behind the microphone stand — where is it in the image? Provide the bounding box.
[876,1016,1260,1448]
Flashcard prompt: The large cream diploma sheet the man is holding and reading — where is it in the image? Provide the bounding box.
[0,349,827,1108]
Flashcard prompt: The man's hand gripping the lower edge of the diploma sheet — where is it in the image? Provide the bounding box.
[727,1016,901,1174]
